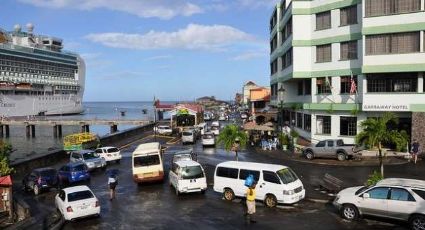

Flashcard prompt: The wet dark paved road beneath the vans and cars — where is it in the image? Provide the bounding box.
[15,126,424,230]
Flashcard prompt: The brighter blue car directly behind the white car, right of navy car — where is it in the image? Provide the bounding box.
[58,162,90,184]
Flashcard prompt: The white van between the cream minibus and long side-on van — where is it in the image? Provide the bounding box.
[168,160,207,195]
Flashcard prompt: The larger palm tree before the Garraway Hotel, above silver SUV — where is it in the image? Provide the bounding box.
[356,112,407,177]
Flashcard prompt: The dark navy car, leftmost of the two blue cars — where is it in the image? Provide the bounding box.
[22,168,58,195]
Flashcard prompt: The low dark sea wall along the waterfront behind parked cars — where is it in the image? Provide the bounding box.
[11,123,155,177]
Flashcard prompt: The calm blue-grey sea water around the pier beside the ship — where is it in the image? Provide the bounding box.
[4,102,159,162]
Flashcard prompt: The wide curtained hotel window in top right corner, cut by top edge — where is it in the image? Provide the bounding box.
[365,0,421,17]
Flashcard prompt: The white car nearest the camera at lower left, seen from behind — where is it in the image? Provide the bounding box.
[55,185,100,220]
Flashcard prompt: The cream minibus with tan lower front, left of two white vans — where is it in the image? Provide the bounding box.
[132,142,164,183]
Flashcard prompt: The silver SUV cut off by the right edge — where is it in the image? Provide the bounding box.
[333,178,425,230]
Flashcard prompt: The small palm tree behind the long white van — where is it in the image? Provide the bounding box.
[217,124,248,161]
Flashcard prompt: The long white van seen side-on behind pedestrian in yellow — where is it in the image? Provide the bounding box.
[214,161,305,207]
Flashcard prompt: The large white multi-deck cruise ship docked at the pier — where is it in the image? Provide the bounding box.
[0,23,85,117]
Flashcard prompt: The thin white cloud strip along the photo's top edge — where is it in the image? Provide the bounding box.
[19,0,203,19]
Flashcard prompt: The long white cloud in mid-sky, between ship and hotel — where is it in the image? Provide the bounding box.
[85,24,255,50]
